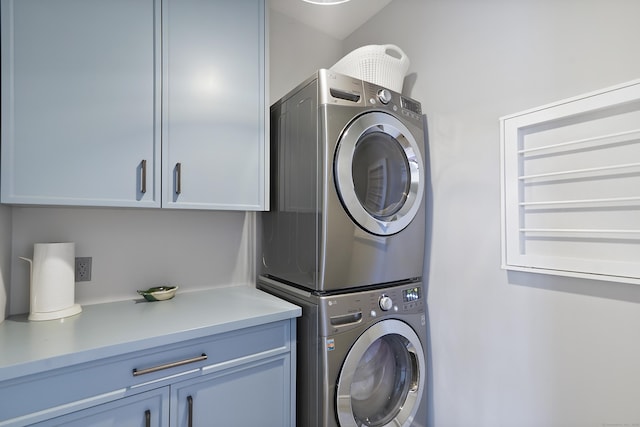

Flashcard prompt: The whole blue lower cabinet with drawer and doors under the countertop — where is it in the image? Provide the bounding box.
[0,319,295,427]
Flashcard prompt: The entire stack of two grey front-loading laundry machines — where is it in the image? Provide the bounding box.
[258,70,427,427]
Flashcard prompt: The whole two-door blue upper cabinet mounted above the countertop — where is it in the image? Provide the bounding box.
[1,0,268,210]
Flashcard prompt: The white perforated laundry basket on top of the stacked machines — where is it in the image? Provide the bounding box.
[331,44,409,92]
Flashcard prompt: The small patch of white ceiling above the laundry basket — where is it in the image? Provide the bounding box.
[269,0,392,40]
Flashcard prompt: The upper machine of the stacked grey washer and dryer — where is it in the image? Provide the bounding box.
[261,70,426,291]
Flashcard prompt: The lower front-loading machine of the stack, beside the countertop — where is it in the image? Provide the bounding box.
[257,277,427,427]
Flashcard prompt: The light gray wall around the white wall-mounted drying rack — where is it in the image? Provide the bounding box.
[345,0,640,427]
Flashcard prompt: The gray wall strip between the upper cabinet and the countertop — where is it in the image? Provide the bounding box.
[9,207,256,314]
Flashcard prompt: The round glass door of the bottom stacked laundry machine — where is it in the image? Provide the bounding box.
[336,320,426,427]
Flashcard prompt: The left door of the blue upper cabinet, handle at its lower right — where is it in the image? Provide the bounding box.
[1,0,161,207]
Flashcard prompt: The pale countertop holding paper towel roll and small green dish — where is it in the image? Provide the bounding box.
[0,286,302,381]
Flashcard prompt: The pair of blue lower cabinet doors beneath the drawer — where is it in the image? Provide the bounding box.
[35,357,291,427]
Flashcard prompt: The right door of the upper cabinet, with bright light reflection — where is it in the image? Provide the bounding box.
[162,0,268,210]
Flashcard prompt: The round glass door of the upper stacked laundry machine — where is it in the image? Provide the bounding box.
[334,112,424,236]
